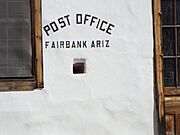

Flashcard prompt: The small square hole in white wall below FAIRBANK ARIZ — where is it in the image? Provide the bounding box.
[73,58,86,74]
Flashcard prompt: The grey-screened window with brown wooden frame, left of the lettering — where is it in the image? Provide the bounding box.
[0,0,43,91]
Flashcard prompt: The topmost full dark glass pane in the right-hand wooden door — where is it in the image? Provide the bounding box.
[162,0,174,25]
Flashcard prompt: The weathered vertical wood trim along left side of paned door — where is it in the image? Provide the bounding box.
[153,0,164,121]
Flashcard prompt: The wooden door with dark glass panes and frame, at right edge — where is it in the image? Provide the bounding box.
[153,0,180,135]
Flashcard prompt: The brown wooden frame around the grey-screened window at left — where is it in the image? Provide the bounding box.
[0,0,44,91]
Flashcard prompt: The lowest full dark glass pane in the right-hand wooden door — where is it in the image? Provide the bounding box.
[163,59,176,87]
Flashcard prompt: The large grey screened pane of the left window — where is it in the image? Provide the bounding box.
[0,0,32,77]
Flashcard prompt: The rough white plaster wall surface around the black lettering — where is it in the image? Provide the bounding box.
[0,0,153,135]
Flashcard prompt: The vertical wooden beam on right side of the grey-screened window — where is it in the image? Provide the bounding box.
[34,0,44,88]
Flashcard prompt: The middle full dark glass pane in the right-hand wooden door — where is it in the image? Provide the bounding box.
[162,28,175,56]
